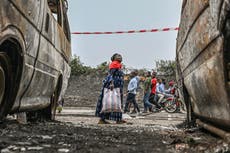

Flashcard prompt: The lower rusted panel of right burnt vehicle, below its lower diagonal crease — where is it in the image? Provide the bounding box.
[184,38,230,120]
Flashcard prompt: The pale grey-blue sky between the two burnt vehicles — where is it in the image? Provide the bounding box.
[68,0,182,69]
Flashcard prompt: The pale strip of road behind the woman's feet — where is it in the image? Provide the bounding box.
[57,107,185,127]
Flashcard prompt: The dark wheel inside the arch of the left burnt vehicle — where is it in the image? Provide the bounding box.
[0,52,13,121]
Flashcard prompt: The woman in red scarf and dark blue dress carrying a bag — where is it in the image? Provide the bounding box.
[95,53,125,124]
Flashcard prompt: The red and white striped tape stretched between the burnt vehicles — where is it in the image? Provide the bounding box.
[72,27,179,35]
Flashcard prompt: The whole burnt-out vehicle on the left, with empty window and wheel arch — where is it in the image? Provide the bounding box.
[0,0,71,120]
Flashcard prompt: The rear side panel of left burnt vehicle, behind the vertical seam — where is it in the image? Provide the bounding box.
[20,0,71,110]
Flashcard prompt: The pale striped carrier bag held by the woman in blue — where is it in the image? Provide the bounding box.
[101,88,121,113]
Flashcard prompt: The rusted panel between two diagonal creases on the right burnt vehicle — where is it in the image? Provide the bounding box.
[178,9,219,71]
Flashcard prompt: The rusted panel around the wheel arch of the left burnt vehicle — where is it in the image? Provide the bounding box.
[0,0,42,111]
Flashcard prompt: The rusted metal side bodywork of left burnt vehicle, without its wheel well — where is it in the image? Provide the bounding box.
[0,0,71,112]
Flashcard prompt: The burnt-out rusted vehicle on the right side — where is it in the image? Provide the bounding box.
[176,0,230,130]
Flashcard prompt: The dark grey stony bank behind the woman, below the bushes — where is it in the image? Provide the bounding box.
[64,74,143,107]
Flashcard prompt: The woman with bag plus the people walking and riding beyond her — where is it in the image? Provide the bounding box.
[95,53,173,124]
